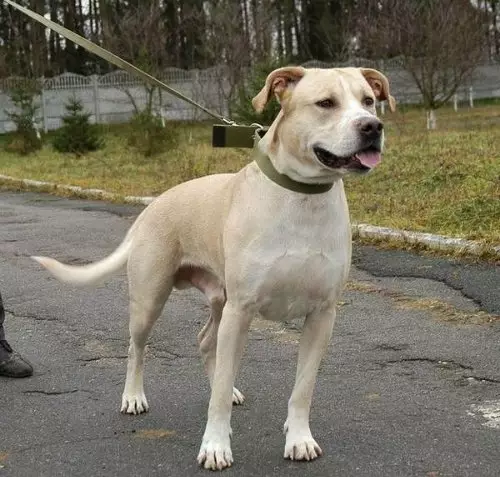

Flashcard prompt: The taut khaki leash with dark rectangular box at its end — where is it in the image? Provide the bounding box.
[3,0,266,148]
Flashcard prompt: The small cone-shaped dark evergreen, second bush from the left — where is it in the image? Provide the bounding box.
[52,97,104,155]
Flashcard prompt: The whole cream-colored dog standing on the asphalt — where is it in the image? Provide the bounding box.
[33,67,394,470]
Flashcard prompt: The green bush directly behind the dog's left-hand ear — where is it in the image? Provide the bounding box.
[232,61,290,126]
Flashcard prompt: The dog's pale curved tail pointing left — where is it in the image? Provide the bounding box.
[31,230,132,287]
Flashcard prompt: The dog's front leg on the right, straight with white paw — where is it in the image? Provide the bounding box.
[284,308,335,460]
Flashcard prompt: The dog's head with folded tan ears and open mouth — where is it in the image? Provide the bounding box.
[252,66,396,183]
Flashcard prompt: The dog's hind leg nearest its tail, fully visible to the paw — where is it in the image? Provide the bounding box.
[121,244,174,414]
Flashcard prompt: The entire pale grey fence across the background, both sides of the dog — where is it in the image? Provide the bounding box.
[0,60,500,133]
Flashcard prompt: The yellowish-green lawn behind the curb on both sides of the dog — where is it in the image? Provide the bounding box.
[0,103,500,244]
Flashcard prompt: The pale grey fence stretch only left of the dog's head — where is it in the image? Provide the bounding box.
[0,68,227,133]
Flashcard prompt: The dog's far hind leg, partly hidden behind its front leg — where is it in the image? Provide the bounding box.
[189,268,245,405]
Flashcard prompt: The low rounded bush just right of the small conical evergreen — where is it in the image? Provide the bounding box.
[128,109,178,157]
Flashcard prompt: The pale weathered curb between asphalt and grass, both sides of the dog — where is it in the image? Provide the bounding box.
[0,174,500,258]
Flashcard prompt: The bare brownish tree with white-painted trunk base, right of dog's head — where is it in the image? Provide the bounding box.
[358,0,485,129]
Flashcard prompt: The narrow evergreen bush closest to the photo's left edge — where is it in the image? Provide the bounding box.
[6,81,42,155]
